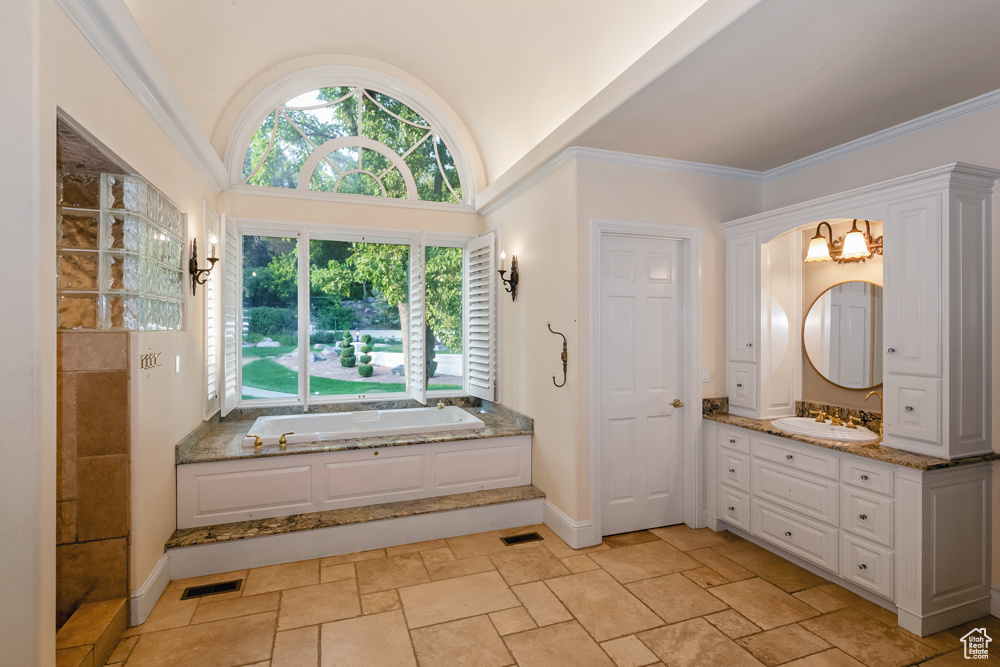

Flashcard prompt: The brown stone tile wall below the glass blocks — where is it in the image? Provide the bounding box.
[56,332,130,627]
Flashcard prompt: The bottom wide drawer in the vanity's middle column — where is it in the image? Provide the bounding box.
[751,498,838,572]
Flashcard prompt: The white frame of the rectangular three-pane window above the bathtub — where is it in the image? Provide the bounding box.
[229,217,478,413]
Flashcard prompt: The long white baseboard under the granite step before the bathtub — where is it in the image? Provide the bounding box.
[167,498,543,579]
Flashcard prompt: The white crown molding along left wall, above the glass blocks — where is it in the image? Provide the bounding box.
[56,0,229,192]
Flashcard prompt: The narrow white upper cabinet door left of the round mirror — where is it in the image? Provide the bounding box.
[726,234,760,362]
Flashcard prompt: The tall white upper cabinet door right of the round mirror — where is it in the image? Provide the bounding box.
[882,195,944,377]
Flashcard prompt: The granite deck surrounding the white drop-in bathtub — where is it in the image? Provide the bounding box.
[175,401,534,465]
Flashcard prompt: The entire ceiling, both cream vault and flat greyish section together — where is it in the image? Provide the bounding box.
[126,0,1000,182]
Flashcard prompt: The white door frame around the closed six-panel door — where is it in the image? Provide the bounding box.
[589,218,705,544]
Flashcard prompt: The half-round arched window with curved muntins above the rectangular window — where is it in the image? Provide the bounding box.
[242,86,467,204]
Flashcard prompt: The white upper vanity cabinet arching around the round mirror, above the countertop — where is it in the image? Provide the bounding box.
[725,163,1000,459]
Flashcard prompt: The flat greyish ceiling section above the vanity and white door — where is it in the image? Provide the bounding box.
[572,0,1000,171]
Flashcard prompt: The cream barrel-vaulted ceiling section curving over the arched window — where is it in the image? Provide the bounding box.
[126,0,706,180]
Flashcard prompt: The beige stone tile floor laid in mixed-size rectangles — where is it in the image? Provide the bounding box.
[108,526,1000,667]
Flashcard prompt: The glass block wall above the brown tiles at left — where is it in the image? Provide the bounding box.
[56,171,187,331]
